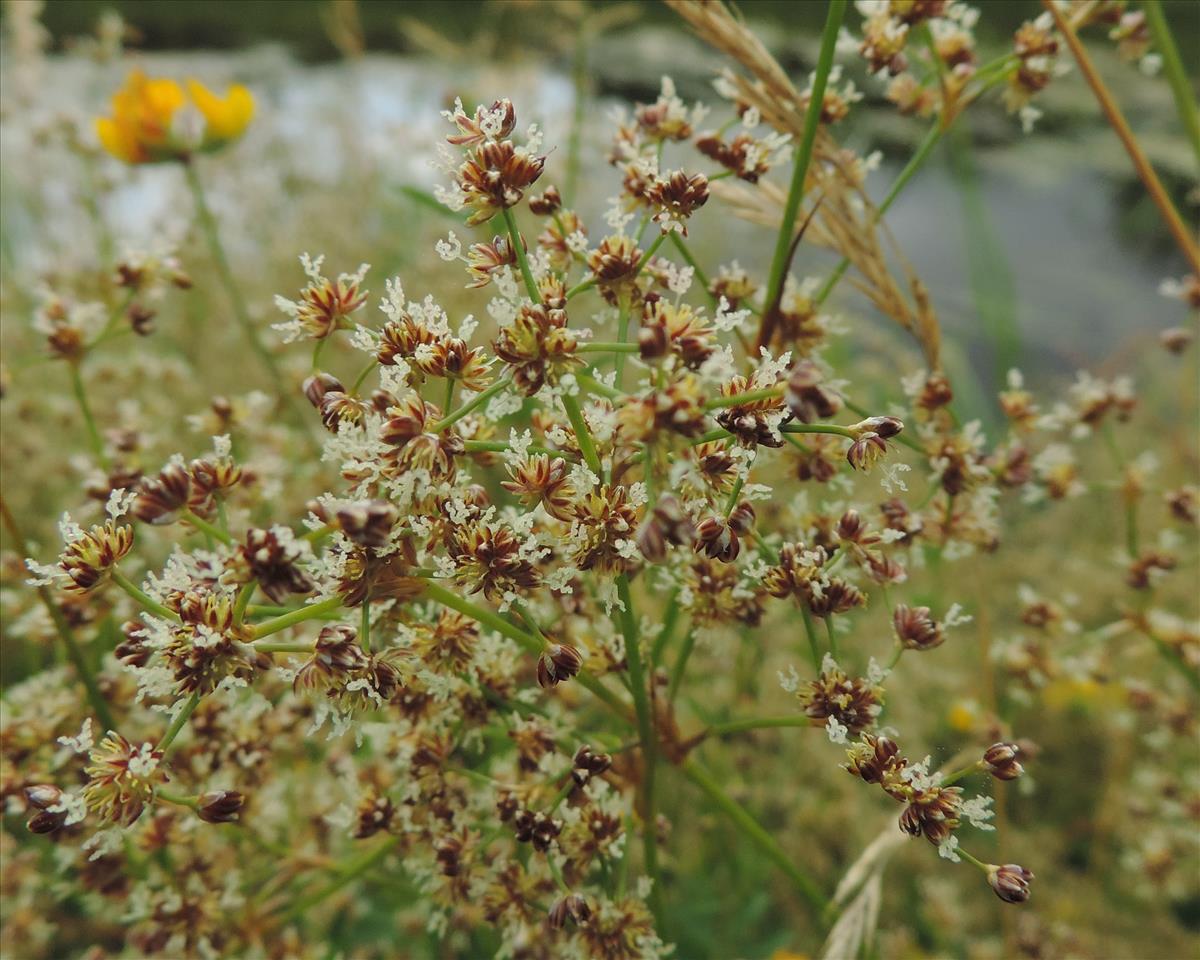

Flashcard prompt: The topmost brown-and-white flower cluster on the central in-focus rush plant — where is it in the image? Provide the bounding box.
[439,100,546,224]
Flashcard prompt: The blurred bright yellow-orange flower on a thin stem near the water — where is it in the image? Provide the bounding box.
[96,70,254,163]
